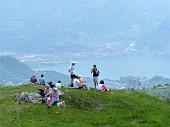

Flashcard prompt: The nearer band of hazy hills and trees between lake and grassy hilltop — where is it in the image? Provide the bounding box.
[0,55,170,89]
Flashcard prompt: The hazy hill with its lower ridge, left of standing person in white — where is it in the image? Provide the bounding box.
[0,55,69,84]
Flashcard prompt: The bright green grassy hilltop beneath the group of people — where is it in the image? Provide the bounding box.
[0,86,170,127]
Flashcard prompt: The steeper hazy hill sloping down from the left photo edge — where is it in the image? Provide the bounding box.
[0,56,35,84]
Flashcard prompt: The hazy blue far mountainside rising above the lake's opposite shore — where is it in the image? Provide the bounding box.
[0,0,170,54]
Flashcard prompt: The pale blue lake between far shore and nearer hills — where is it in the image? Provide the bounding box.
[36,55,170,79]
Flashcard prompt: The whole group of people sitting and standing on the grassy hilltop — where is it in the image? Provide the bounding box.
[30,62,112,108]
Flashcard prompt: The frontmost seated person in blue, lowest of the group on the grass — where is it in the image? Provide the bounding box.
[47,87,59,108]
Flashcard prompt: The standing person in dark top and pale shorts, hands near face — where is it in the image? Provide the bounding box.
[91,65,100,88]
